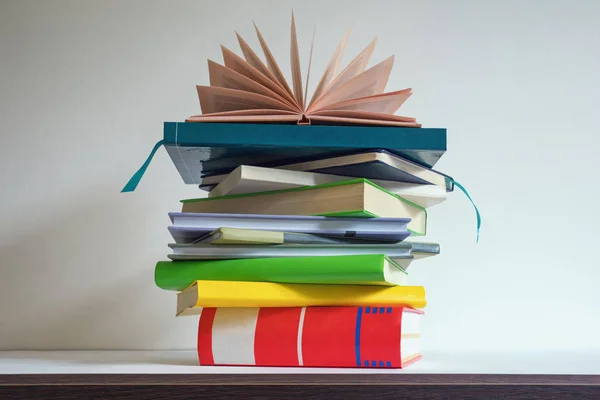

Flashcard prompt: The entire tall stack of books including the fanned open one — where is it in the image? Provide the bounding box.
[124,17,478,368]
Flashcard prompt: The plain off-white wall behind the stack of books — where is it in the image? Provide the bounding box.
[0,0,600,352]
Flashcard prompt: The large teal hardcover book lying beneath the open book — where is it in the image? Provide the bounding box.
[123,122,446,192]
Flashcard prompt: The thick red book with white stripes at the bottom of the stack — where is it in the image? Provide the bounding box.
[198,307,423,368]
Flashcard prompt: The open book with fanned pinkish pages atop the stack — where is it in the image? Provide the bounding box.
[186,13,421,127]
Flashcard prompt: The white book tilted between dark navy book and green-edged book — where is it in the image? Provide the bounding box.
[208,165,446,208]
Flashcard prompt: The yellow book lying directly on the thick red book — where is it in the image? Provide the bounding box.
[177,281,427,316]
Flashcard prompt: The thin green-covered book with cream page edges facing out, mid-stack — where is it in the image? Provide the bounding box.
[181,178,427,236]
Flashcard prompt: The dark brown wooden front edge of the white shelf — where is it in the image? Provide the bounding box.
[0,373,600,400]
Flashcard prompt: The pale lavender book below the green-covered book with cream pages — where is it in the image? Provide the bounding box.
[169,212,410,243]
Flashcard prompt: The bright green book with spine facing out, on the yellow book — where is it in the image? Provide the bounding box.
[154,254,407,291]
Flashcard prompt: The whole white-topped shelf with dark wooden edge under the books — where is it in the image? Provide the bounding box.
[0,351,600,400]
